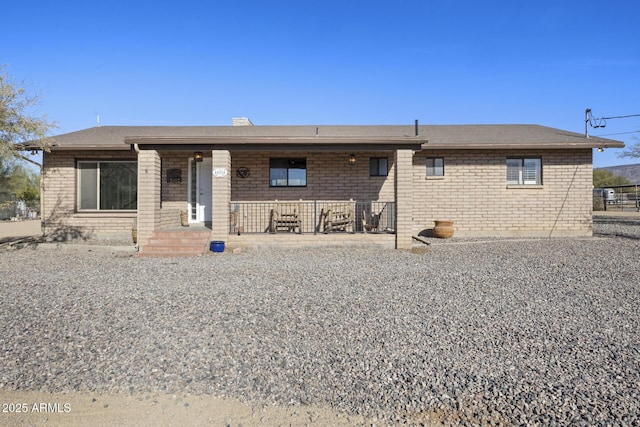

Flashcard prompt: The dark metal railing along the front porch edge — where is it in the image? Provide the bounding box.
[229,200,395,234]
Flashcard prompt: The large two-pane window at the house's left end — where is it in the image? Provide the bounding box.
[78,161,138,211]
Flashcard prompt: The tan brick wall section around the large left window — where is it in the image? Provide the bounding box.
[42,151,136,239]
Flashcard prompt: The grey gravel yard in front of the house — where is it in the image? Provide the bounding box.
[0,218,640,426]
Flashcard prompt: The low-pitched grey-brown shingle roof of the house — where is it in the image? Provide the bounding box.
[42,125,624,150]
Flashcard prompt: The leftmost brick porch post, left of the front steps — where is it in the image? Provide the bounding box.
[138,150,162,250]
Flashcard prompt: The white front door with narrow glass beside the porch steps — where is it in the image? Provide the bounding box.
[189,157,211,223]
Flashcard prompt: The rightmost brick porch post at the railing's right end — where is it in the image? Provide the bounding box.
[394,149,414,249]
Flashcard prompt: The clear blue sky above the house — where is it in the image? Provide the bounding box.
[0,0,640,167]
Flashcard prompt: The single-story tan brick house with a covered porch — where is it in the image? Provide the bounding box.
[36,119,624,253]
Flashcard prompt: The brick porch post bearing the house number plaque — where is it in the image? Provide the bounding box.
[211,150,231,241]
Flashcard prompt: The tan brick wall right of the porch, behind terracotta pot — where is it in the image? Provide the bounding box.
[413,149,592,236]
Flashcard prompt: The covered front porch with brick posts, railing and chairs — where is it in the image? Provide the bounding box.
[126,129,425,252]
